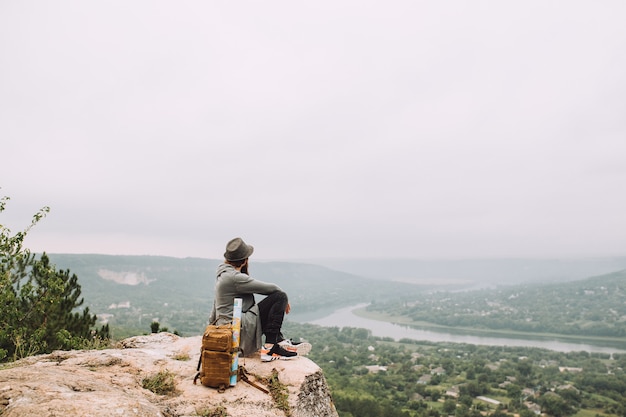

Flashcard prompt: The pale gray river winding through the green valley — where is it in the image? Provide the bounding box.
[307,304,626,353]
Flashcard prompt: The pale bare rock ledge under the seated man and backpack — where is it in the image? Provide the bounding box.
[0,333,337,417]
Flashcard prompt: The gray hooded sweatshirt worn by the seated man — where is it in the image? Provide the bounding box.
[209,263,281,357]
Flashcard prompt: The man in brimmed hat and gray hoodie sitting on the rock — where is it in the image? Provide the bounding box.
[209,237,311,361]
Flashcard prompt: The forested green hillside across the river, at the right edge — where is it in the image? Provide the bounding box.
[368,270,626,338]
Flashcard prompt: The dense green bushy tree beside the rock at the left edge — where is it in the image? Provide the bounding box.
[0,193,109,361]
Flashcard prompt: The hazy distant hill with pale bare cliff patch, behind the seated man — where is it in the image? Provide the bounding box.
[48,254,426,337]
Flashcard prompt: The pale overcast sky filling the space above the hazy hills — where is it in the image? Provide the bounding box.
[0,0,626,260]
